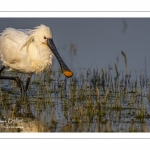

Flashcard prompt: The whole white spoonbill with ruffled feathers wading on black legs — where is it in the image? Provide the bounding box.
[0,25,73,93]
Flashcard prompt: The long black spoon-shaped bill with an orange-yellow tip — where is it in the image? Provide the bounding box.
[47,39,73,77]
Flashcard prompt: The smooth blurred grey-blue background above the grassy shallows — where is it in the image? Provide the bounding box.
[0,18,150,74]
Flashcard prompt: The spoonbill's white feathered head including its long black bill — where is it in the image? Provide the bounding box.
[33,25,73,77]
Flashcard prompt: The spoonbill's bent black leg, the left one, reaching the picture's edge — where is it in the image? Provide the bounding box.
[0,66,26,94]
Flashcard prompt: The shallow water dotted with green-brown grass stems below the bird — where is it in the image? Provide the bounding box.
[0,67,150,132]
